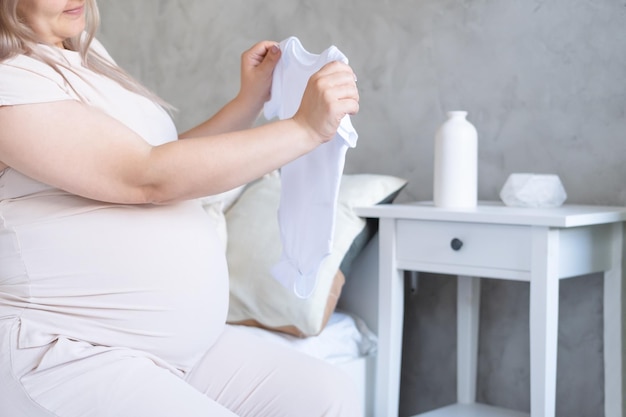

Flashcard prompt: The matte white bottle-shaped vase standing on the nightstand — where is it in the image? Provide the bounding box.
[433,111,478,209]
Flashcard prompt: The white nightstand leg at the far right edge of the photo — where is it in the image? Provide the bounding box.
[604,223,626,417]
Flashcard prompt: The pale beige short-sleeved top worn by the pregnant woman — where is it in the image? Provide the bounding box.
[0,43,228,370]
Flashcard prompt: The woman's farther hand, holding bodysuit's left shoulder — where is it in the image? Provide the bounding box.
[239,41,280,108]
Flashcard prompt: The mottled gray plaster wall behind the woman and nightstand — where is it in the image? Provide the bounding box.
[100,0,626,417]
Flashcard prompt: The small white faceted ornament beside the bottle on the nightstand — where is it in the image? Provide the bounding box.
[500,173,567,208]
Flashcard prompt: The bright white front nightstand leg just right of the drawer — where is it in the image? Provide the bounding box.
[530,227,559,417]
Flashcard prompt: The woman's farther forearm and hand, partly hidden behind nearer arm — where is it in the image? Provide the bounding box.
[179,41,281,139]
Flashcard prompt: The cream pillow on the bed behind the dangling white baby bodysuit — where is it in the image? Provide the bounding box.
[226,174,406,336]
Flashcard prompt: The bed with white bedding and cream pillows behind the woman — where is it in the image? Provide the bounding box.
[202,173,406,416]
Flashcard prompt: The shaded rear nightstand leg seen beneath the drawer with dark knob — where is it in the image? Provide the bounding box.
[457,276,480,404]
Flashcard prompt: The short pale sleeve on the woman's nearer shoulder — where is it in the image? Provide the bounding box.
[0,56,76,106]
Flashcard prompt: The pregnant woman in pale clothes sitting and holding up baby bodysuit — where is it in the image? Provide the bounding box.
[0,0,361,417]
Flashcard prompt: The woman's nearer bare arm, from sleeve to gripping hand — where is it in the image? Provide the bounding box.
[0,62,359,203]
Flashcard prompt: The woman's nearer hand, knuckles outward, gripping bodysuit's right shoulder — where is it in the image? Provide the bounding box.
[293,61,359,143]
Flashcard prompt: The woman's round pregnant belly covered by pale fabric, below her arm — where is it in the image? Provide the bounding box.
[0,197,228,369]
